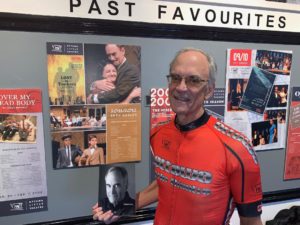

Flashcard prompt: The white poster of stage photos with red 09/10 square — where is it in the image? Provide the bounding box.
[225,49,292,150]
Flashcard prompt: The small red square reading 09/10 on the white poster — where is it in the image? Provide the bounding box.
[230,49,252,66]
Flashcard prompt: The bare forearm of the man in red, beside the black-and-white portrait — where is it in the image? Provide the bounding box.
[135,180,158,209]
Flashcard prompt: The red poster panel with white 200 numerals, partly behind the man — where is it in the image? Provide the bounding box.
[150,88,175,128]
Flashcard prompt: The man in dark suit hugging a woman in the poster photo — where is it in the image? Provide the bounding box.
[91,44,141,104]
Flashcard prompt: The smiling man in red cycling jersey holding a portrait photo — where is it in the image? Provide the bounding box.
[93,49,262,225]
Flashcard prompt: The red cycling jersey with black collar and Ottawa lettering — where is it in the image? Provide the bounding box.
[151,113,262,225]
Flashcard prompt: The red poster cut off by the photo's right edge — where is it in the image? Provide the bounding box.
[284,87,300,180]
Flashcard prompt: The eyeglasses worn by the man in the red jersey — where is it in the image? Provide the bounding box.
[167,74,208,87]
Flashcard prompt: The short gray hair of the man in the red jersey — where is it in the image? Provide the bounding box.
[169,48,217,85]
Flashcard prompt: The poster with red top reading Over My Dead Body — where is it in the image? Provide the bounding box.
[0,89,48,216]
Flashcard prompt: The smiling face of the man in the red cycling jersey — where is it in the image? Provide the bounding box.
[169,51,214,123]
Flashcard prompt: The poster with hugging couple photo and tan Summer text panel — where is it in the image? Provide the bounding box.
[47,42,141,169]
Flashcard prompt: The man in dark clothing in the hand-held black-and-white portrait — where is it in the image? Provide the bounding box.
[100,166,135,216]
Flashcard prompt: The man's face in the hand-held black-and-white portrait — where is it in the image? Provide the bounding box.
[105,171,127,206]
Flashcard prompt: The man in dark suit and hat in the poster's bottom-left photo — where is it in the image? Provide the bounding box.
[56,134,82,168]
